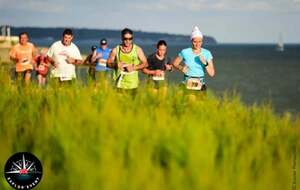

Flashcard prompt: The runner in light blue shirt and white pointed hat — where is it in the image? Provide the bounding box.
[173,26,215,91]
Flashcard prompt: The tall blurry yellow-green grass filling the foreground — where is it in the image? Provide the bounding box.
[0,68,300,190]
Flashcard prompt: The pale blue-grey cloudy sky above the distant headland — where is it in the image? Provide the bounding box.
[0,0,300,43]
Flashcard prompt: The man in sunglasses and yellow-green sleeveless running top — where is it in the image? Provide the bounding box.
[107,28,148,93]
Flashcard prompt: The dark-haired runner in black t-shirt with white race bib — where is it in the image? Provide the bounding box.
[143,40,172,89]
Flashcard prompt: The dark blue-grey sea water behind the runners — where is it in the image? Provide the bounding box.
[33,37,300,113]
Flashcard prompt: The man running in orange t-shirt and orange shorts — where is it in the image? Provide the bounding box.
[9,32,35,84]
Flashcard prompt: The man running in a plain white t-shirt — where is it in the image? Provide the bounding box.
[47,29,82,83]
